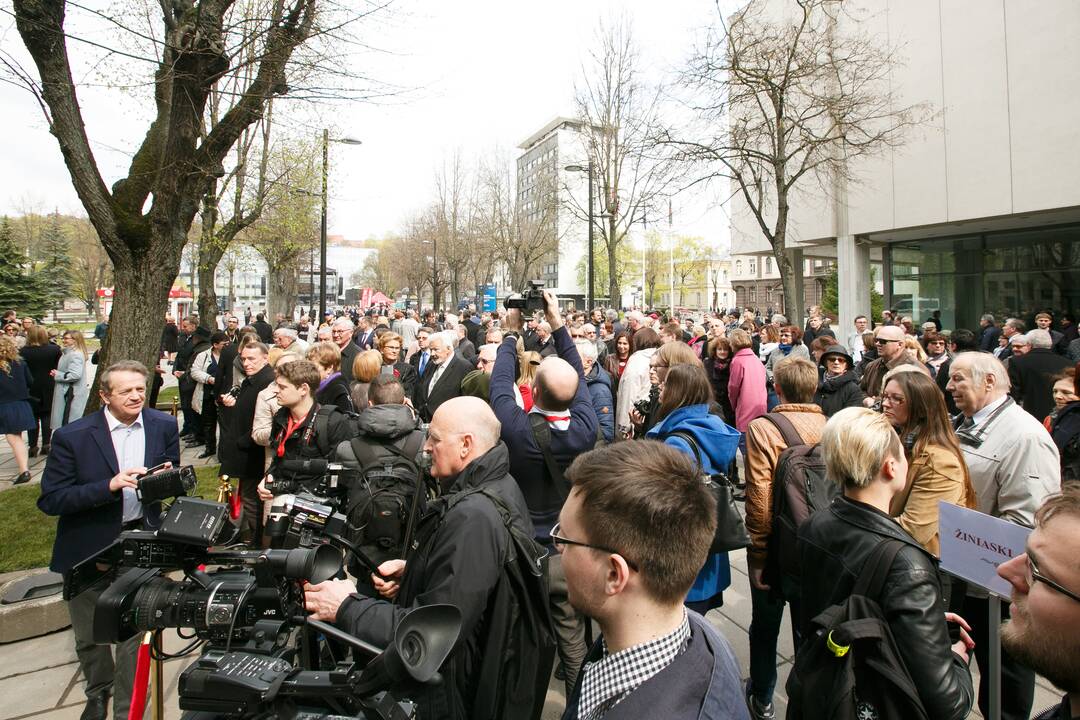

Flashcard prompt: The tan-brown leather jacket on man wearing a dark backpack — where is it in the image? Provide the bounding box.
[746,403,827,567]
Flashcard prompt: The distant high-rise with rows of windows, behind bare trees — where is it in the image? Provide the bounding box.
[514,118,603,304]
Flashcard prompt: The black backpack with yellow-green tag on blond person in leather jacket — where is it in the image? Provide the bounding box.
[786,540,928,720]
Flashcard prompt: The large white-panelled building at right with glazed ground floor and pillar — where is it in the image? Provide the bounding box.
[732,0,1080,328]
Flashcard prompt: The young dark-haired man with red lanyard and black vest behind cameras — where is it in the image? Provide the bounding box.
[258,361,352,501]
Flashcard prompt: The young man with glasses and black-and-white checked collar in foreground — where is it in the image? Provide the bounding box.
[551,440,747,720]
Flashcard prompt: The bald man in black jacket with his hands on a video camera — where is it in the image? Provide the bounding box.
[307,397,553,720]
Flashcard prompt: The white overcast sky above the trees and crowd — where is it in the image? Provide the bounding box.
[0,0,728,246]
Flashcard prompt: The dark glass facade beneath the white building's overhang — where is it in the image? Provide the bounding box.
[890,225,1080,330]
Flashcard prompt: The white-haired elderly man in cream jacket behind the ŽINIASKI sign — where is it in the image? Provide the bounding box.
[946,352,1061,720]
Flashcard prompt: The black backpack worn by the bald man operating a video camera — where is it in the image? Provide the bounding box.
[442,487,556,720]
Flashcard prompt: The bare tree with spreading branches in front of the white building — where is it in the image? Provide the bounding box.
[662,0,930,310]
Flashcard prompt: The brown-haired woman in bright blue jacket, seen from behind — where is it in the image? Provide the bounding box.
[646,367,740,614]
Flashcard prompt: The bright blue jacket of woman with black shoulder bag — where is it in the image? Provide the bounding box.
[645,405,739,602]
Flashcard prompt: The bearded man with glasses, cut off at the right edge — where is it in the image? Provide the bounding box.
[998,485,1080,720]
